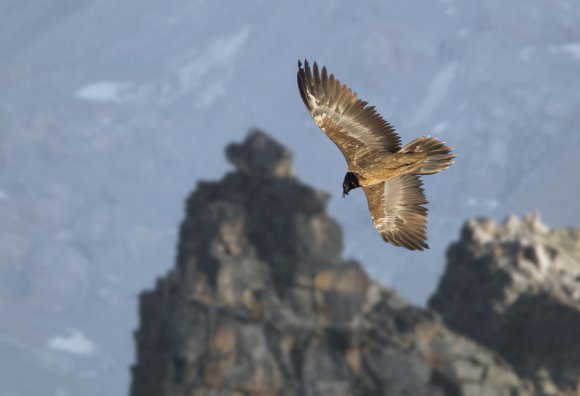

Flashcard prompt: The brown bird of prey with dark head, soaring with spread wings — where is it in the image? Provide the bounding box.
[297,60,455,250]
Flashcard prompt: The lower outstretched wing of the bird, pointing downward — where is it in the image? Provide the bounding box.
[363,175,429,250]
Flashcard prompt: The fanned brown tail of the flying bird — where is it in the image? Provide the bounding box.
[400,136,455,175]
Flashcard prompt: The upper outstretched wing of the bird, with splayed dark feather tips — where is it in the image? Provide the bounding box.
[298,60,401,165]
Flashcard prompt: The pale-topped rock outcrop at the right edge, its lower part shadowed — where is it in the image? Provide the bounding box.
[429,215,580,395]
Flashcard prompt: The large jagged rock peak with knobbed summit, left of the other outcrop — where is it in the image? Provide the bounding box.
[131,131,532,396]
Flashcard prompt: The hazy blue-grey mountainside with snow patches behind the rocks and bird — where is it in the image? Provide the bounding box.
[0,0,580,396]
